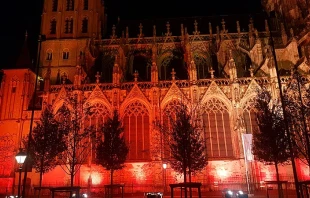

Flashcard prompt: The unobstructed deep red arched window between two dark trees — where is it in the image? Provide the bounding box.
[123,101,150,161]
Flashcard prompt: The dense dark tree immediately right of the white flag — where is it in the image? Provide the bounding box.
[253,90,290,197]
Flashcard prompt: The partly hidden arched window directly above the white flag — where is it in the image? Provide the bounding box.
[243,100,258,133]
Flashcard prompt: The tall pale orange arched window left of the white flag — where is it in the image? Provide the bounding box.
[202,98,233,158]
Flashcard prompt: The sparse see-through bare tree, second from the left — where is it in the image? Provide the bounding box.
[58,94,95,187]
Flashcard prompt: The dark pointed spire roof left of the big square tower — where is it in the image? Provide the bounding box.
[16,31,33,68]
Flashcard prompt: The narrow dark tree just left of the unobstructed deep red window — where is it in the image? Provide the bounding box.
[96,110,129,196]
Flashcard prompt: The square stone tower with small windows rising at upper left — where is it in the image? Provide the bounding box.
[39,0,105,84]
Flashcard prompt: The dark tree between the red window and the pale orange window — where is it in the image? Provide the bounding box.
[155,103,208,196]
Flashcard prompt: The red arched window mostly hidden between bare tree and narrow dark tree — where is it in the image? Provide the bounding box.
[84,103,110,163]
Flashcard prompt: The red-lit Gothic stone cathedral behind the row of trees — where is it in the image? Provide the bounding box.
[0,0,310,194]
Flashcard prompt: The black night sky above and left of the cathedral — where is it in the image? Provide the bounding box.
[0,0,261,68]
